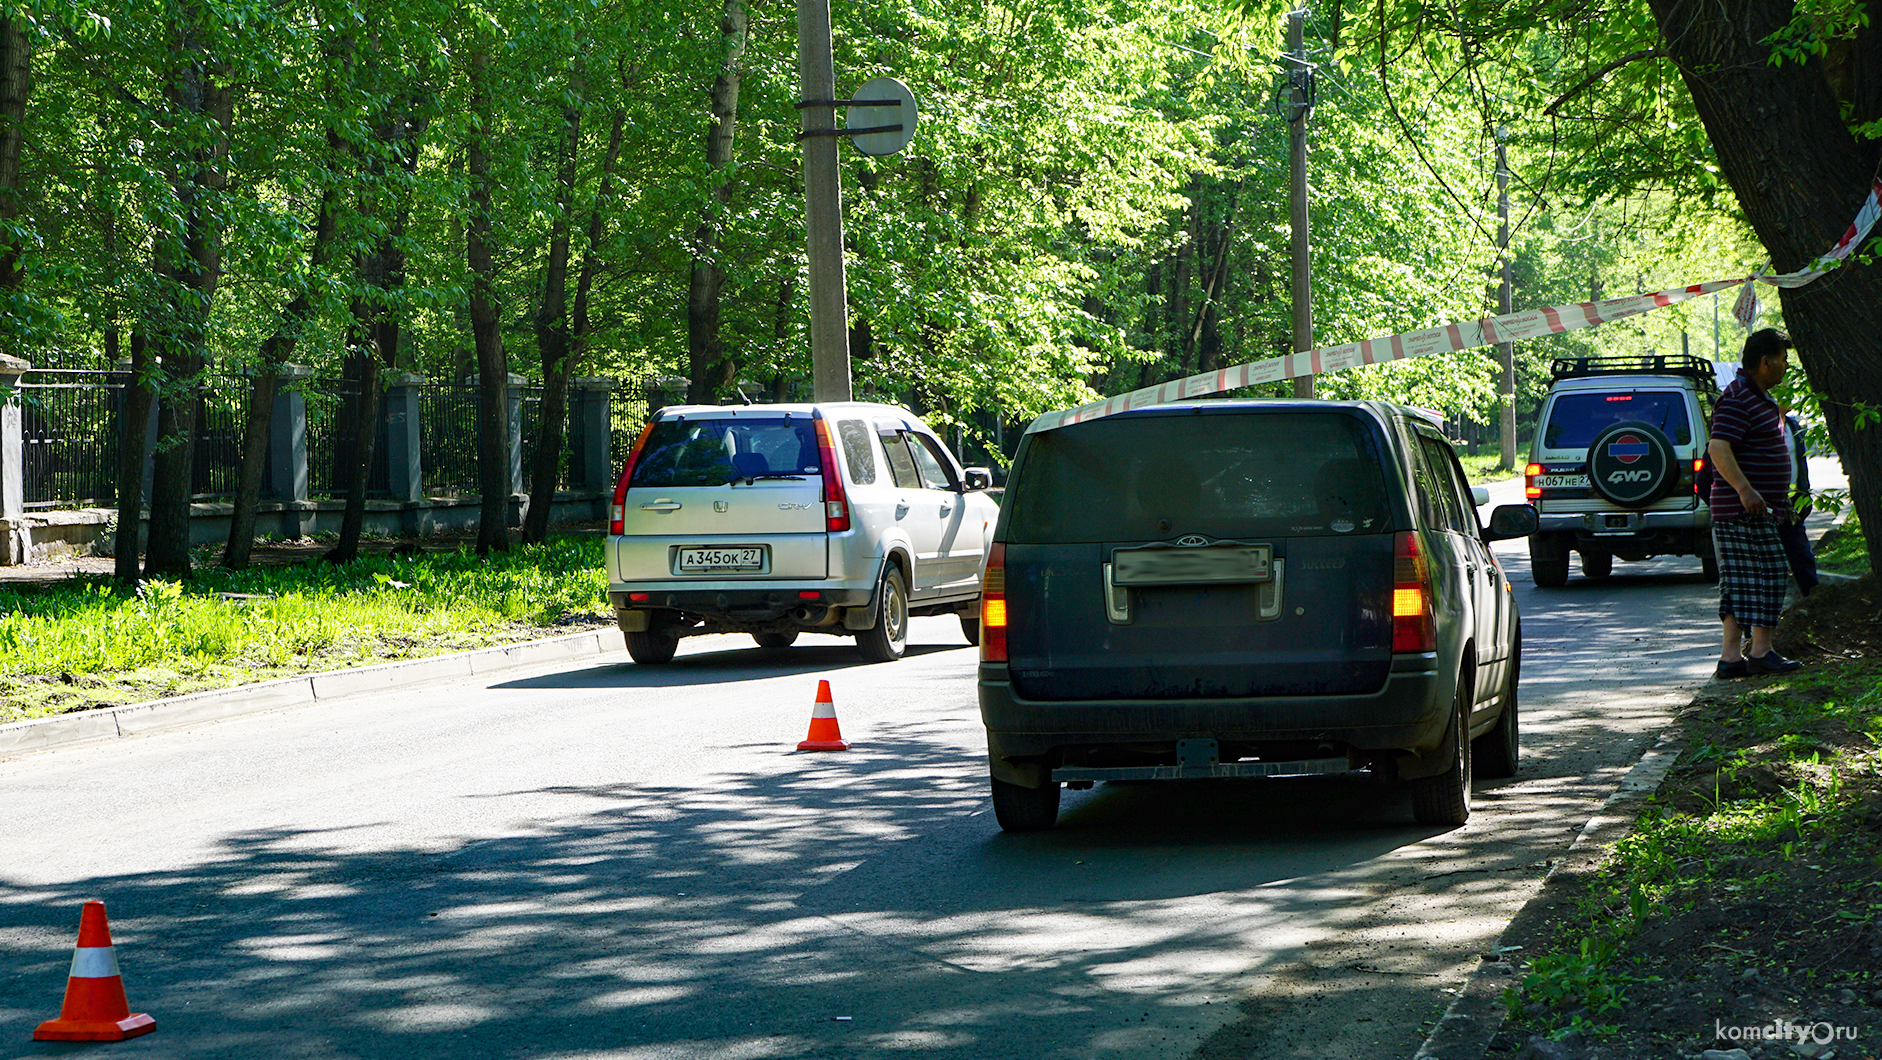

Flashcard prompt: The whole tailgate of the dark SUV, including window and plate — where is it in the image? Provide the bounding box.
[997,403,1402,700]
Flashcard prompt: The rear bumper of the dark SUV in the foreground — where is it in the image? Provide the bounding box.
[981,653,1457,768]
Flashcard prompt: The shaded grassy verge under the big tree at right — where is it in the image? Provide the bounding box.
[1491,578,1882,1060]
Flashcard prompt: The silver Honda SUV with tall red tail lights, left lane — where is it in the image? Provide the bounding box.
[608,403,999,663]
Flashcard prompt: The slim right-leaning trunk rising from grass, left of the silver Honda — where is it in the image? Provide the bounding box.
[523,75,582,544]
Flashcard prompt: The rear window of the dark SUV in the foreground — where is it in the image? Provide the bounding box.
[1007,412,1389,544]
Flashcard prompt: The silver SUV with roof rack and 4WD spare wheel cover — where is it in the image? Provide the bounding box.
[1524,354,1718,587]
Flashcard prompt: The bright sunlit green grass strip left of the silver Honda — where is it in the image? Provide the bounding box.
[0,537,608,723]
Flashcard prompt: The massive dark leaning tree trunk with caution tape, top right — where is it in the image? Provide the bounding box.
[1651,0,1882,574]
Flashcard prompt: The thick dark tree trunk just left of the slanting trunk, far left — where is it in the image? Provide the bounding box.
[143,18,233,578]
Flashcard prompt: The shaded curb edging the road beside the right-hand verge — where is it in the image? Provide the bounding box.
[1412,731,1684,1060]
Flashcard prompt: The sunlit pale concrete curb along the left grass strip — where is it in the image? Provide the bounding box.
[0,631,614,761]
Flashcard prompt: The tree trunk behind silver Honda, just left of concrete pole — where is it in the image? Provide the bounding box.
[687,0,745,405]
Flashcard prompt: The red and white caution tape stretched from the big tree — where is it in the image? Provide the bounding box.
[1033,179,1882,431]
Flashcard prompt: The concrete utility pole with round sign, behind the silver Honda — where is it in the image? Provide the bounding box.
[798,0,851,401]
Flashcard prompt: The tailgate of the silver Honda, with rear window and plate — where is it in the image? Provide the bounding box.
[615,407,828,582]
